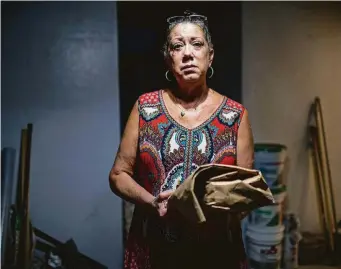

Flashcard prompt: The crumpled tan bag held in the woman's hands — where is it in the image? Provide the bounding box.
[168,164,275,224]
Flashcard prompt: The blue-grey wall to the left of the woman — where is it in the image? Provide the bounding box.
[1,1,123,269]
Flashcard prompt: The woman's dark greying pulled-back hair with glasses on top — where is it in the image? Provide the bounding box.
[162,10,213,58]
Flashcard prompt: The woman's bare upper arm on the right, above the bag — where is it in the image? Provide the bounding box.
[237,109,254,169]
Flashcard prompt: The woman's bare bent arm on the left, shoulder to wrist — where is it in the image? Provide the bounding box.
[109,102,155,208]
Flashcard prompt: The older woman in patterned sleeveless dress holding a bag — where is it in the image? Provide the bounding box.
[110,9,253,269]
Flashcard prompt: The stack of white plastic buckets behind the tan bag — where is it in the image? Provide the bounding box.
[244,144,298,269]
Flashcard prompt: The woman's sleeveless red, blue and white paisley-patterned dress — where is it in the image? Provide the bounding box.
[124,90,246,269]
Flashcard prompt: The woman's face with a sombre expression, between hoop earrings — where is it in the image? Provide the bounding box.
[168,22,213,83]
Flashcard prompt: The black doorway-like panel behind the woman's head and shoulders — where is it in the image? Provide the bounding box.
[117,1,242,129]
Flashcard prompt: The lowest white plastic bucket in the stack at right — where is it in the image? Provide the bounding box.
[246,225,284,269]
